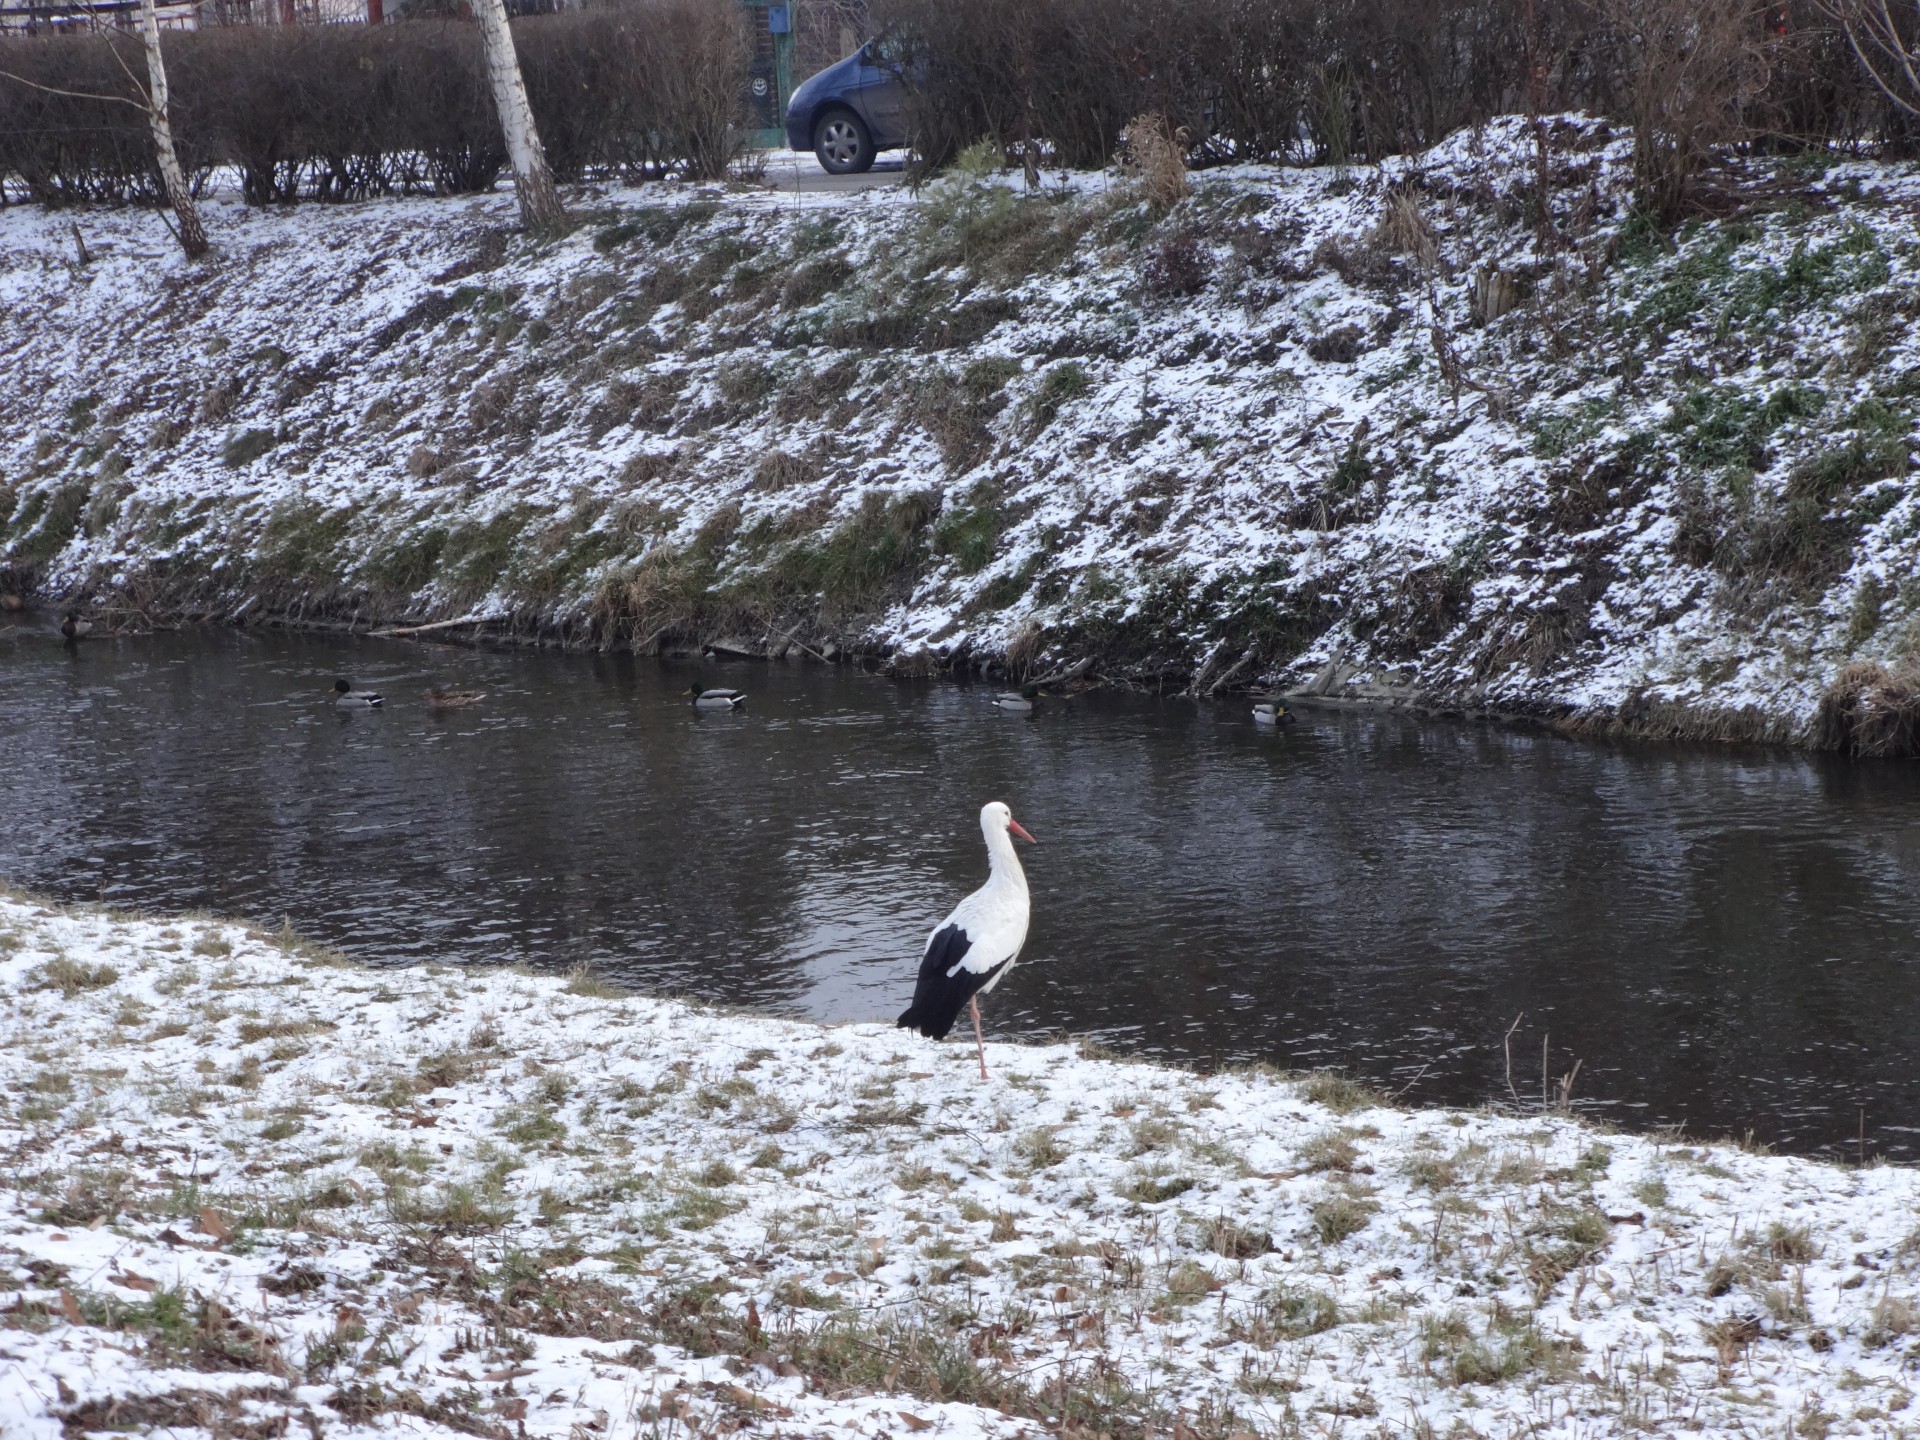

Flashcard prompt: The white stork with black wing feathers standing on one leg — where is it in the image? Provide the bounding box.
[897,801,1033,1079]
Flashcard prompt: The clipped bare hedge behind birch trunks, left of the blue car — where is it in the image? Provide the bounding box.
[0,0,749,205]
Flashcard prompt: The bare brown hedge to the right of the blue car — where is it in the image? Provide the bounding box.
[872,0,1910,183]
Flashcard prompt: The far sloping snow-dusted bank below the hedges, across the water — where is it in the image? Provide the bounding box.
[0,119,1920,739]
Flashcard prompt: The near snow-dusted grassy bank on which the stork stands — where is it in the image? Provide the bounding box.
[11,899,1920,1440]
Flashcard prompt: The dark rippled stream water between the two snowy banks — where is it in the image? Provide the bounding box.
[0,630,1920,1158]
